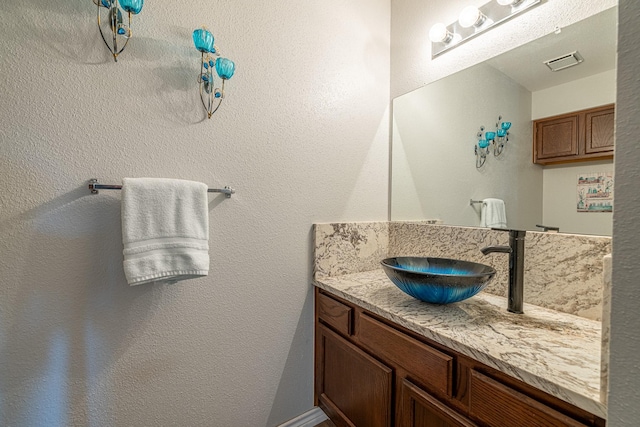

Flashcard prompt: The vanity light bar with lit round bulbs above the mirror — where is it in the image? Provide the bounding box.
[429,0,546,58]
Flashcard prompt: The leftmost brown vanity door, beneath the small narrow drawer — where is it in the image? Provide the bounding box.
[316,325,393,427]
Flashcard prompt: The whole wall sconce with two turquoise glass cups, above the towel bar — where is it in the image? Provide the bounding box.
[193,27,236,118]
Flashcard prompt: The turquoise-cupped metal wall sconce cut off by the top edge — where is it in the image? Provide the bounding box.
[93,0,144,62]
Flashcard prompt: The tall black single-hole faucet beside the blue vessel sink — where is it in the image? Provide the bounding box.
[480,228,527,314]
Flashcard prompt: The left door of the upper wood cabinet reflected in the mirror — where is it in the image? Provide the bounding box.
[534,114,579,162]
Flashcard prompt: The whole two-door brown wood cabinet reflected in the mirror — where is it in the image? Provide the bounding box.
[533,104,615,165]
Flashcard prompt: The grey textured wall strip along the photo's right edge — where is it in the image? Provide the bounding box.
[607,0,640,427]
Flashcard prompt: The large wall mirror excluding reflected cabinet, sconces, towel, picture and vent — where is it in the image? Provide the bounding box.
[391,7,617,235]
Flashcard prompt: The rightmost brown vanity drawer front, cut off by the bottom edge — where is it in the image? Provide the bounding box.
[469,370,587,427]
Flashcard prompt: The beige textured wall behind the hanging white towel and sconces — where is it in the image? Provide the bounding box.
[0,0,390,427]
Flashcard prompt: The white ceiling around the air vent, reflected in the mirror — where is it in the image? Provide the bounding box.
[486,7,618,92]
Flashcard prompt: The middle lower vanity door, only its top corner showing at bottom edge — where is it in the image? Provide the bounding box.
[398,378,477,427]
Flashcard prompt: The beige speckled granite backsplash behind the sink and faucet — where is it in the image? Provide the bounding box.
[314,222,611,320]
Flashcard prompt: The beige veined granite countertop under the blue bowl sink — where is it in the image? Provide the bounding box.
[314,269,607,418]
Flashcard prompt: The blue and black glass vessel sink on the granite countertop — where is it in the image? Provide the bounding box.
[381,257,496,304]
